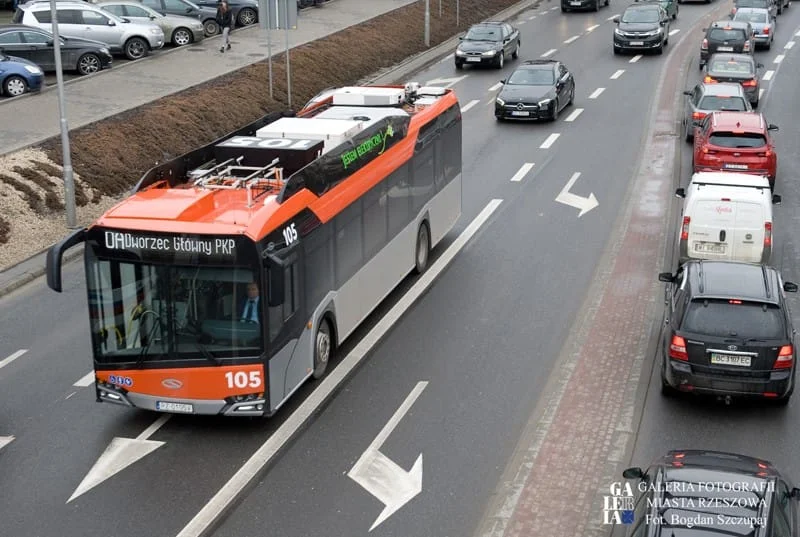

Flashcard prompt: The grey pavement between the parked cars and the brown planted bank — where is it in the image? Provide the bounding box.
[0,0,421,155]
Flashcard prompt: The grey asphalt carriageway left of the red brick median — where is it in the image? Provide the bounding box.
[0,4,736,537]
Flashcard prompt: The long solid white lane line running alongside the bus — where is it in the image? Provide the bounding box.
[178,199,503,537]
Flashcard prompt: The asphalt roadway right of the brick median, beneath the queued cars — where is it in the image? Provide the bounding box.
[633,0,800,492]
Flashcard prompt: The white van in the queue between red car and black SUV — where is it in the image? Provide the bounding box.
[675,172,781,263]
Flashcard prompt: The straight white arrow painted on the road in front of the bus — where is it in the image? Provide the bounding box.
[67,414,172,503]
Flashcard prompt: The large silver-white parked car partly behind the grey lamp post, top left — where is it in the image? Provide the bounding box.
[13,1,164,60]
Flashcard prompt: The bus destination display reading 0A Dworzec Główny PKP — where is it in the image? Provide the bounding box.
[105,231,236,257]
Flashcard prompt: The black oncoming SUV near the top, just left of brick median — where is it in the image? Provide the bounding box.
[611,2,669,54]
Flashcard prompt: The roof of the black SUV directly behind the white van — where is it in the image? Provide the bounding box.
[684,260,780,305]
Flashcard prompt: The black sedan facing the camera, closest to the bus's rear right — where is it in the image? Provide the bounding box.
[494,60,575,121]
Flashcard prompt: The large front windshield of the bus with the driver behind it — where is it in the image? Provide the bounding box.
[87,255,263,367]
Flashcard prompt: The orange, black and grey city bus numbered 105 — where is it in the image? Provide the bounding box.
[47,83,462,416]
